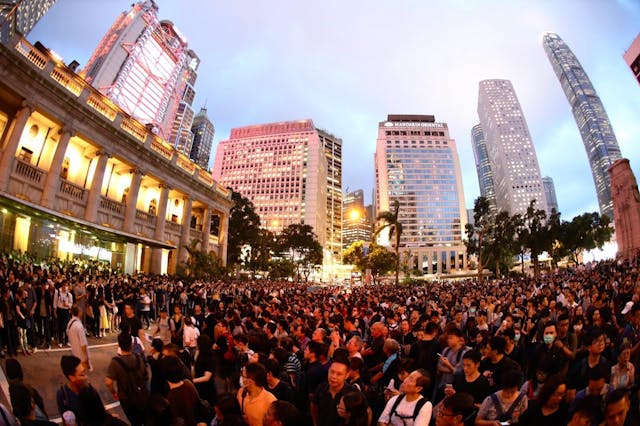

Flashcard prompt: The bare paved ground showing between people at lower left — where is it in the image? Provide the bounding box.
[0,333,126,422]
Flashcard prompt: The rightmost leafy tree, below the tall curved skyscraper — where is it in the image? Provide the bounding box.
[559,212,613,263]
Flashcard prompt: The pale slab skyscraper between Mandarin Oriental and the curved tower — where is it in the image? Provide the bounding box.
[478,79,547,214]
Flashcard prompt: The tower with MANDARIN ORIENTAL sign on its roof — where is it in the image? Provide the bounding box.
[375,115,467,274]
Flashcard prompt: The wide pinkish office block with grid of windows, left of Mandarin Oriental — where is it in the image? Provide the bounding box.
[212,120,329,250]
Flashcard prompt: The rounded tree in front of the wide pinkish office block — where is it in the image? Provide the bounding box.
[277,223,322,281]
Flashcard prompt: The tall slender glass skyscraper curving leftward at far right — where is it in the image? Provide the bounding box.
[542,33,621,219]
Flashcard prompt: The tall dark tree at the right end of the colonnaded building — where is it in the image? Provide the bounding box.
[227,191,260,265]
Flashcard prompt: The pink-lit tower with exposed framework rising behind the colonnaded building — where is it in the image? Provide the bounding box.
[82,0,199,151]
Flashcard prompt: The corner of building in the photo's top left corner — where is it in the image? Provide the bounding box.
[0,0,56,43]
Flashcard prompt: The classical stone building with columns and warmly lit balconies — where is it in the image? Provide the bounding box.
[0,37,233,273]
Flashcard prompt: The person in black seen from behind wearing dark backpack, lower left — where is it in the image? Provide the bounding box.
[105,332,149,426]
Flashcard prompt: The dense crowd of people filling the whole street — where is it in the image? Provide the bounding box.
[0,250,640,426]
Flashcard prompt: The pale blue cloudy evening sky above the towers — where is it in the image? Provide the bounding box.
[27,0,640,220]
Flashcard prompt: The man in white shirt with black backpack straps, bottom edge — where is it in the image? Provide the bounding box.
[378,370,433,426]
